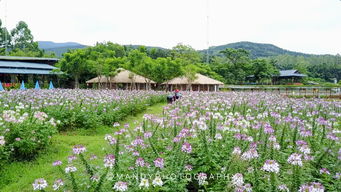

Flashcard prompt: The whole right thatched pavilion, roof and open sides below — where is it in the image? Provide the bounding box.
[163,73,224,91]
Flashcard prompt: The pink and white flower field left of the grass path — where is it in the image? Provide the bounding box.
[0,89,165,166]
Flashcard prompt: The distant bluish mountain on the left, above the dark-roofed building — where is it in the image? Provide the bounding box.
[38,41,87,57]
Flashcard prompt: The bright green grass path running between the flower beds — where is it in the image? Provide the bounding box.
[0,103,165,192]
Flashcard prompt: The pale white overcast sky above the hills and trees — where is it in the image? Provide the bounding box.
[0,0,341,54]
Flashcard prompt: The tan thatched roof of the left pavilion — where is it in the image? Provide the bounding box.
[86,69,155,83]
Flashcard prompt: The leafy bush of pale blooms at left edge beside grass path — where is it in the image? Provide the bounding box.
[0,108,57,162]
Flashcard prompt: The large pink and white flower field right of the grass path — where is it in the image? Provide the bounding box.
[27,92,341,192]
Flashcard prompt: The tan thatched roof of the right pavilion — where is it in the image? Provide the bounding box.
[163,73,224,85]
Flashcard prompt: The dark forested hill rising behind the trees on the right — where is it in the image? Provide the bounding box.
[200,41,313,58]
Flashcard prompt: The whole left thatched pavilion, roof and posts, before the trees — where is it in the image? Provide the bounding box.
[86,68,156,90]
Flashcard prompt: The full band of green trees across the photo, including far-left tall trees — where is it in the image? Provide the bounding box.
[0,20,341,87]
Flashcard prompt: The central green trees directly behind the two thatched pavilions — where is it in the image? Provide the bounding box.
[58,42,278,87]
